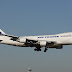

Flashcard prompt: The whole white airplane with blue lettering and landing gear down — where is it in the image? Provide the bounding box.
[0,29,72,52]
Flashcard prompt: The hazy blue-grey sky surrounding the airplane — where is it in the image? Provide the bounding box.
[0,0,72,72]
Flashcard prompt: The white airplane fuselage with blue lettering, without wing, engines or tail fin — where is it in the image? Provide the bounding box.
[0,32,72,46]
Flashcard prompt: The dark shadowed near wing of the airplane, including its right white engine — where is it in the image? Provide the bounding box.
[25,39,56,47]
